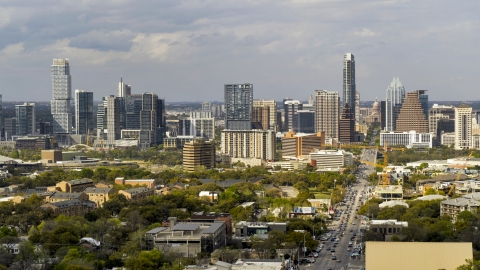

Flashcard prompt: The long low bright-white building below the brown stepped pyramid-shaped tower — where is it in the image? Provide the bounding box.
[380,131,432,148]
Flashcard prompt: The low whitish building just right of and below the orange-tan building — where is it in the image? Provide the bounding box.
[309,150,353,168]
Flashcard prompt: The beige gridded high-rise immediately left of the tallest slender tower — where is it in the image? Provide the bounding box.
[315,90,340,139]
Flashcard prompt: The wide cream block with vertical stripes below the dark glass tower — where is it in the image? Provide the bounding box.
[221,129,275,160]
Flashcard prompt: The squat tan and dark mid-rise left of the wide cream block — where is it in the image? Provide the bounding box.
[183,139,215,172]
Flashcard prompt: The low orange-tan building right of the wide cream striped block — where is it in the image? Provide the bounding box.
[282,131,325,159]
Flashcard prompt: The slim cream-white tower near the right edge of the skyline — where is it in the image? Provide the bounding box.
[455,103,472,149]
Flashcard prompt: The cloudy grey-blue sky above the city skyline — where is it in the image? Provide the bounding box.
[0,0,480,102]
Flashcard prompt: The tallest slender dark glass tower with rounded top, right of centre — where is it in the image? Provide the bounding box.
[343,53,354,119]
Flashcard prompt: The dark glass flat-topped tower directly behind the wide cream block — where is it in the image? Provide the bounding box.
[224,83,253,130]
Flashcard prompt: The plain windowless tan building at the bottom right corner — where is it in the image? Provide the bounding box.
[365,242,473,270]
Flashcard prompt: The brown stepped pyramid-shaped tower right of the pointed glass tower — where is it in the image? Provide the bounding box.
[396,90,428,133]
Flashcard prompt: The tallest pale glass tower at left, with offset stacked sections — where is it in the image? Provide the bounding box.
[50,59,72,134]
